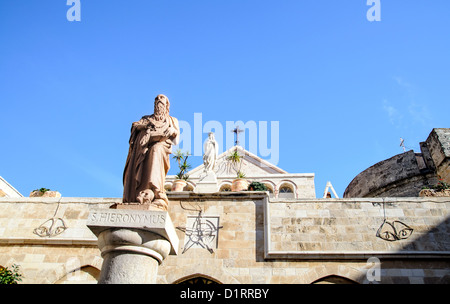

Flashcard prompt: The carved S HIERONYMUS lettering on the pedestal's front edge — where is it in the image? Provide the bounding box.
[89,211,166,225]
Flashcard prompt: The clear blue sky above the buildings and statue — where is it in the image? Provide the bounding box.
[0,0,450,197]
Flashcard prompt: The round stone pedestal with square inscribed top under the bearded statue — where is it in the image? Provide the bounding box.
[87,209,179,284]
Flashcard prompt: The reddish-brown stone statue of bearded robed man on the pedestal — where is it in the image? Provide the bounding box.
[123,94,180,210]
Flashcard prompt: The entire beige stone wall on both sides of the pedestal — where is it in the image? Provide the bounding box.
[0,192,450,284]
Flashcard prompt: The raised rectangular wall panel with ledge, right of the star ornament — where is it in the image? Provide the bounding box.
[266,198,450,259]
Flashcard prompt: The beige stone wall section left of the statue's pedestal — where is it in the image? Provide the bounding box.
[0,197,113,284]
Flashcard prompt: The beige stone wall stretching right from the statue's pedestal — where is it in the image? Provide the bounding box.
[158,194,450,284]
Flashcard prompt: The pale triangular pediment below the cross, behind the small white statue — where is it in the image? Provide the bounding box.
[189,146,287,178]
